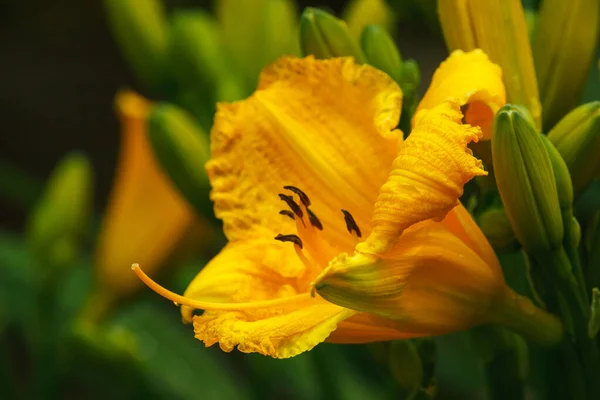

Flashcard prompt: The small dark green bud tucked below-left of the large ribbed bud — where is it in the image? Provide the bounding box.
[477,208,521,253]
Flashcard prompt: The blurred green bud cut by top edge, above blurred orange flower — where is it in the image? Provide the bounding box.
[104,0,168,90]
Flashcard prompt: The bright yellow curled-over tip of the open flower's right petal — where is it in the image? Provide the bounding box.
[417,50,506,140]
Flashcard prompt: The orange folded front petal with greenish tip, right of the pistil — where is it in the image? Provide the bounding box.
[316,221,505,336]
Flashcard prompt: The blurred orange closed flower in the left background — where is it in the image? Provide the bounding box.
[95,92,194,295]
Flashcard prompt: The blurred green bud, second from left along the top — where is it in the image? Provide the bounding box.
[169,10,228,129]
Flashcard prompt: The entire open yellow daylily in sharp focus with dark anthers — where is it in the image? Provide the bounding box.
[132,52,560,358]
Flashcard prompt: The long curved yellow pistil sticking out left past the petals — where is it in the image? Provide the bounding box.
[131,264,310,311]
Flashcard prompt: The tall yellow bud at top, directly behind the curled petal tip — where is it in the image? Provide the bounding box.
[438,0,542,127]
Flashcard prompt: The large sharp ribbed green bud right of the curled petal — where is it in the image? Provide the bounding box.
[492,105,564,253]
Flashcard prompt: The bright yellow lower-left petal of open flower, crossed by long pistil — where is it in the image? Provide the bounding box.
[181,239,354,358]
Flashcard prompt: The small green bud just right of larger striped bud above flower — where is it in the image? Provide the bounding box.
[361,25,403,82]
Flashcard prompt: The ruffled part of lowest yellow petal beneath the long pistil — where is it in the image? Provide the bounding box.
[194,298,355,358]
